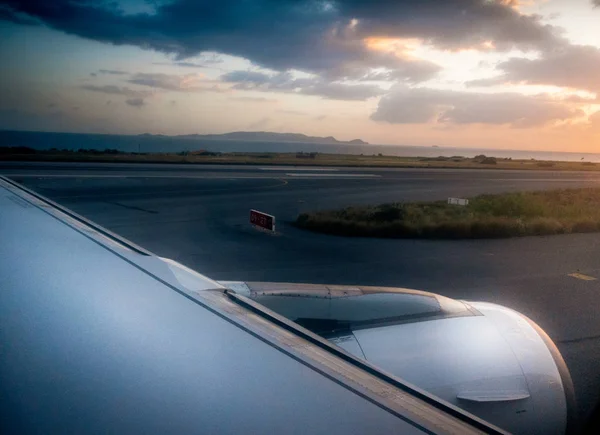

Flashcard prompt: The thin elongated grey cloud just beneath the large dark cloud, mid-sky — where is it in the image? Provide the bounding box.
[220,71,384,100]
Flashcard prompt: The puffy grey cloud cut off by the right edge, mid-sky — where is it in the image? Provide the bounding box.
[468,45,600,92]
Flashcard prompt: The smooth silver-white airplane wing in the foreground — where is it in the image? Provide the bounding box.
[0,177,556,434]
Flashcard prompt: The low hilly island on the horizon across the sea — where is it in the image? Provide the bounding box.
[140,131,369,145]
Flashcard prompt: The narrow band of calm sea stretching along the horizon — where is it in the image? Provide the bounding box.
[0,130,600,162]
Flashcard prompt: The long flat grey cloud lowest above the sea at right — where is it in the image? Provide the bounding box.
[371,87,583,127]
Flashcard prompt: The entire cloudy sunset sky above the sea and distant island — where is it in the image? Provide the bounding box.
[0,0,600,152]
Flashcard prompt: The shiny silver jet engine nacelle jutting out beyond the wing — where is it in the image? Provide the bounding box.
[222,282,575,434]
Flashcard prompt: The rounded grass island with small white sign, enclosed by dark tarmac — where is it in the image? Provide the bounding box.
[295,188,600,239]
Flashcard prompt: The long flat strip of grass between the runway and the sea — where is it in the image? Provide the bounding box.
[0,147,600,171]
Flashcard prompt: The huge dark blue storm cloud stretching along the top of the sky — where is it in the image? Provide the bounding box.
[0,0,559,81]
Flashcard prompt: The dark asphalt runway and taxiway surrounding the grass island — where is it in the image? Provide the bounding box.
[0,163,600,426]
